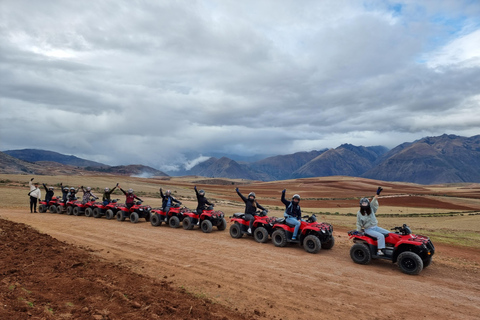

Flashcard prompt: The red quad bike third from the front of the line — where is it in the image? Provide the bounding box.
[230,210,277,243]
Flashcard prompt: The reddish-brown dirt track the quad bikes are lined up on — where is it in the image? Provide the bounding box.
[0,209,480,319]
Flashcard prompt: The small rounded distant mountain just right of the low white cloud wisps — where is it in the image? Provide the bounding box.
[188,157,263,180]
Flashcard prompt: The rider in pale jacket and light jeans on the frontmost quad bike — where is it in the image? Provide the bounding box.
[357,187,390,256]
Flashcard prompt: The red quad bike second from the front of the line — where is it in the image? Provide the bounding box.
[272,214,335,253]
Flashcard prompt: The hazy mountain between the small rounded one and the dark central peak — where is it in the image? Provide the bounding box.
[248,149,327,180]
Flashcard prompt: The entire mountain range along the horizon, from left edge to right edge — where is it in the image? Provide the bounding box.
[0,134,480,184]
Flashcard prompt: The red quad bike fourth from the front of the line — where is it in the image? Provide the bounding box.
[182,206,227,233]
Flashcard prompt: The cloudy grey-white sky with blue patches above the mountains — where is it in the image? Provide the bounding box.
[0,0,480,170]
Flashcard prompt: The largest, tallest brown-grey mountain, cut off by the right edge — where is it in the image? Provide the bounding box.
[362,134,480,184]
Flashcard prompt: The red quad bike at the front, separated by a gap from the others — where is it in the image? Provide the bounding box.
[348,224,435,274]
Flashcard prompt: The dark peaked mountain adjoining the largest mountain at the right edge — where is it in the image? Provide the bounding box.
[292,144,388,178]
